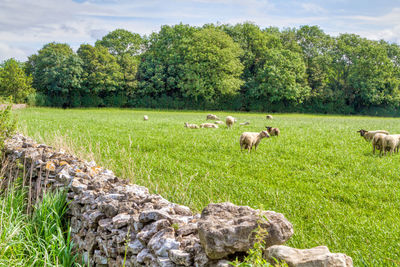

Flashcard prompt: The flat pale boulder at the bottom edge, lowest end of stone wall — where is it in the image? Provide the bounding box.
[264,246,353,267]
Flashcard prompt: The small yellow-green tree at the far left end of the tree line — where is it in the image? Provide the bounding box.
[0,58,34,103]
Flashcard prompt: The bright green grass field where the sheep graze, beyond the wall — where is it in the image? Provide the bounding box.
[16,108,400,266]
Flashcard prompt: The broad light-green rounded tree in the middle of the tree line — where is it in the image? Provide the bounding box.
[179,27,243,102]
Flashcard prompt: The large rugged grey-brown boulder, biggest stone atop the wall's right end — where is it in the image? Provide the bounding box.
[198,202,293,259]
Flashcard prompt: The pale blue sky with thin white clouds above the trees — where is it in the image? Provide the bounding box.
[0,0,400,62]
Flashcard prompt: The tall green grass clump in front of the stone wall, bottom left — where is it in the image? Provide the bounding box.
[0,183,79,266]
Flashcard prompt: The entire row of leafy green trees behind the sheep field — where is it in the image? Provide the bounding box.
[0,23,400,115]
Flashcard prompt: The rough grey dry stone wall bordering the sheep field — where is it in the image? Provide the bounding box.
[0,135,352,266]
